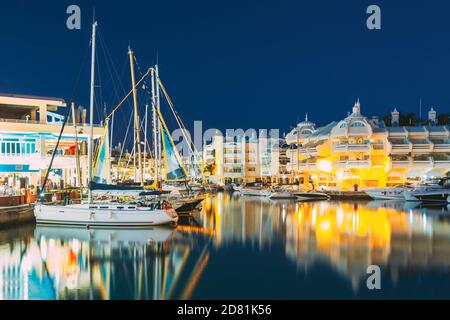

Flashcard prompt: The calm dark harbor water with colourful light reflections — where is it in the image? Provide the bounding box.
[0,193,450,299]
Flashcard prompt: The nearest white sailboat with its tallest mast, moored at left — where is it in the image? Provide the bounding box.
[34,22,178,227]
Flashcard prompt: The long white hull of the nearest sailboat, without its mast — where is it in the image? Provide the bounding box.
[34,201,178,227]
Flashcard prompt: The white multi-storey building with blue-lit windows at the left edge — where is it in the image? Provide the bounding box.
[0,95,103,188]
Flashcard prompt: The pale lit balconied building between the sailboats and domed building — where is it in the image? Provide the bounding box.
[203,135,286,183]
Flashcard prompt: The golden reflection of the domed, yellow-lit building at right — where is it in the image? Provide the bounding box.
[286,203,450,289]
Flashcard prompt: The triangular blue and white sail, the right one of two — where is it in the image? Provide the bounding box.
[158,111,189,181]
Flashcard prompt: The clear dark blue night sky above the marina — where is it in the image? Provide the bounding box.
[0,0,450,138]
